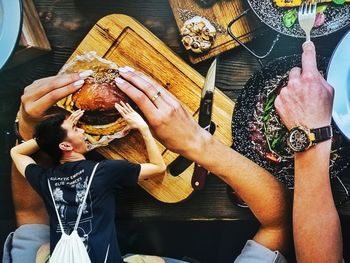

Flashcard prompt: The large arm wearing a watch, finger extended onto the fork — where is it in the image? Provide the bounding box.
[275,42,342,262]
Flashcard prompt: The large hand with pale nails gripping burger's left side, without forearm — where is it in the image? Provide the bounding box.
[18,70,92,139]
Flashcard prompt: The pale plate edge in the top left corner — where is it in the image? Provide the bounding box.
[0,0,22,70]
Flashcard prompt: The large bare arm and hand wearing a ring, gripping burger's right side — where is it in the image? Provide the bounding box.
[116,68,291,251]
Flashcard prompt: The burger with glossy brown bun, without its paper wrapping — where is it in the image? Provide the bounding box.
[72,69,130,135]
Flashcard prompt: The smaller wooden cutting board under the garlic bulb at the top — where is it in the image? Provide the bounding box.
[169,0,258,64]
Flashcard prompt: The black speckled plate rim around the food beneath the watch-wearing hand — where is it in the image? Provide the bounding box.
[232,55,350,188]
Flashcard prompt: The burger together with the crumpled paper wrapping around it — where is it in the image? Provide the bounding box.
[58,52,131,144]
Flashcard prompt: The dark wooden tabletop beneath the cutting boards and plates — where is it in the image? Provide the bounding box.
[0,0,350,228]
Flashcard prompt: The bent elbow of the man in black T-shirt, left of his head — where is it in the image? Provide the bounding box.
[10,139,39,176]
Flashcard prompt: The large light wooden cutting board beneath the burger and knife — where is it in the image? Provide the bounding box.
[62,14,234,203]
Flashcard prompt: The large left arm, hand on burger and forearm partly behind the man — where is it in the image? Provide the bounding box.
[11,71,91,226]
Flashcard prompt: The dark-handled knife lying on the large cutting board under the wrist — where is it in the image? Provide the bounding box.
[168,59,217,190]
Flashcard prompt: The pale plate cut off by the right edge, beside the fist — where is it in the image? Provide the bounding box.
[327,31,350,140]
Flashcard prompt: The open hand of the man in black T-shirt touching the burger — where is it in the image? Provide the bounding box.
[115,102,148,131]
